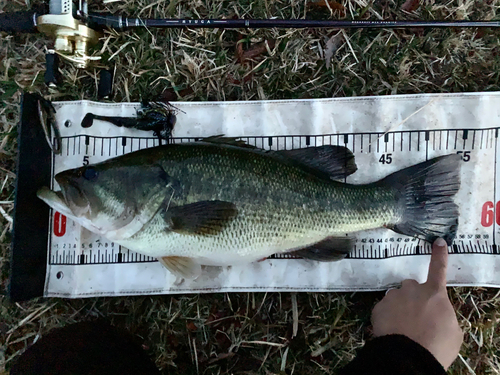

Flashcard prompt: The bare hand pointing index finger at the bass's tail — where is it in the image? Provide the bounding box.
[372,238,463,369]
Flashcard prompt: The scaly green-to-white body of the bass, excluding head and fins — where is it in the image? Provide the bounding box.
[112,146,395,264]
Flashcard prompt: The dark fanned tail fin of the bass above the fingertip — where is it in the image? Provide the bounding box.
[379,155,460,245]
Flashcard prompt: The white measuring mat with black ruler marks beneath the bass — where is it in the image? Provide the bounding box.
[42,93,500,296]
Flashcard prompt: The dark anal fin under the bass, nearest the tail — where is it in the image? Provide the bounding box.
[290,237,354,262]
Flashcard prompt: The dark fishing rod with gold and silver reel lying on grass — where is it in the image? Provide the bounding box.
[0,0,500,86]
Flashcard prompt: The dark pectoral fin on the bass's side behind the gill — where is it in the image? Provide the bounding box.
[164,201,238,235]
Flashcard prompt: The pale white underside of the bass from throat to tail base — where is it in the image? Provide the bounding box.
[115,203,394,266]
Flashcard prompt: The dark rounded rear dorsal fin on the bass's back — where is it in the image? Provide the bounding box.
[275,145,358,180]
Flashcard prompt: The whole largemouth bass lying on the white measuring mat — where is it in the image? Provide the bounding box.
[38,137,460,278]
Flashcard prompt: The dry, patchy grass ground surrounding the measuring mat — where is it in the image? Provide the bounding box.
[0,0,500,375]
